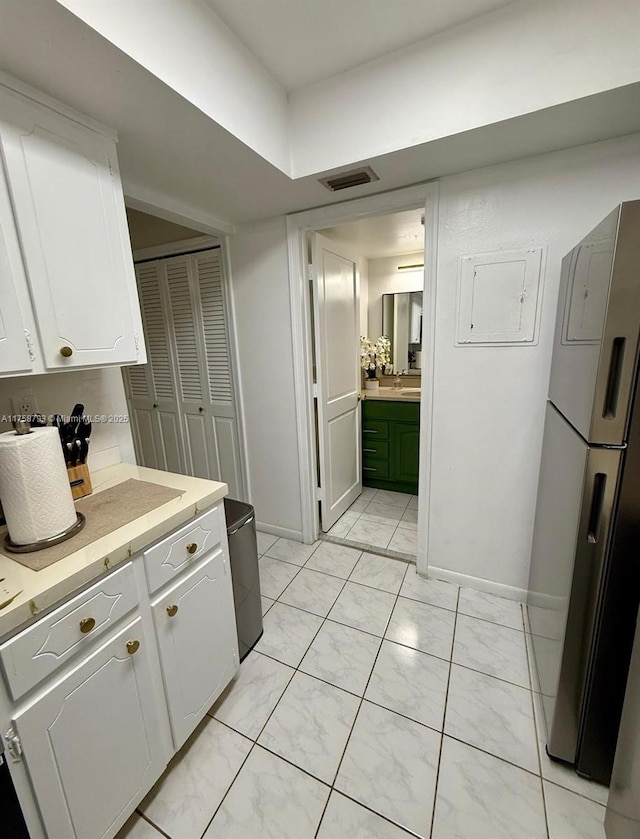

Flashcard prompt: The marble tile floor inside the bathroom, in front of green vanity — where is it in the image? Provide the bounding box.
[321,487,418,562]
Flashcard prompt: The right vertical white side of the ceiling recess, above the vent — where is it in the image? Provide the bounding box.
[289,0,640,178]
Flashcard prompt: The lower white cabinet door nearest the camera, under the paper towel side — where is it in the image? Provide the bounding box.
[14,618,169,839]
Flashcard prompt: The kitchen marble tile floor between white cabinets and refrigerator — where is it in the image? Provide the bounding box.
[118,534,607,839]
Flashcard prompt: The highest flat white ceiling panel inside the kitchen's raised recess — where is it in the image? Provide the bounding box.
[205,0,511,91]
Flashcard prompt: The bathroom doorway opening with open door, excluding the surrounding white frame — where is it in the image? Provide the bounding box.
[308,208,424,562]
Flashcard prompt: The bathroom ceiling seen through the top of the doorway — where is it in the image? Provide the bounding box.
[322,210,424,259]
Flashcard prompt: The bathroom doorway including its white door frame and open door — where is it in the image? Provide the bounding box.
[288,184,437,573]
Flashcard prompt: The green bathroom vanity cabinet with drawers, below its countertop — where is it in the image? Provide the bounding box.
[362,396,420,495]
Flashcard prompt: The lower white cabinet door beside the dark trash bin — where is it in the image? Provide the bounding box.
[153,551,238,749]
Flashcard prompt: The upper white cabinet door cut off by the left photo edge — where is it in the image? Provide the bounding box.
[0,158,35,375]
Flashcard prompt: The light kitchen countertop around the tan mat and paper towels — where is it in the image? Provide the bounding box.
[0,463,228,637]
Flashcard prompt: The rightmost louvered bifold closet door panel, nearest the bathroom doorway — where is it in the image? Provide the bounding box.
[192,248,242,498]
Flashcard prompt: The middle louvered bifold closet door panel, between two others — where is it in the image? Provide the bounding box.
[164,255,222,480]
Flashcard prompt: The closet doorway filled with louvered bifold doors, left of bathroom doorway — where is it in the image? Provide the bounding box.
[122,208,246,499]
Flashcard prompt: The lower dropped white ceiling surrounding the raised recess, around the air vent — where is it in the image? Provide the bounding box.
[0,0,640,233]
